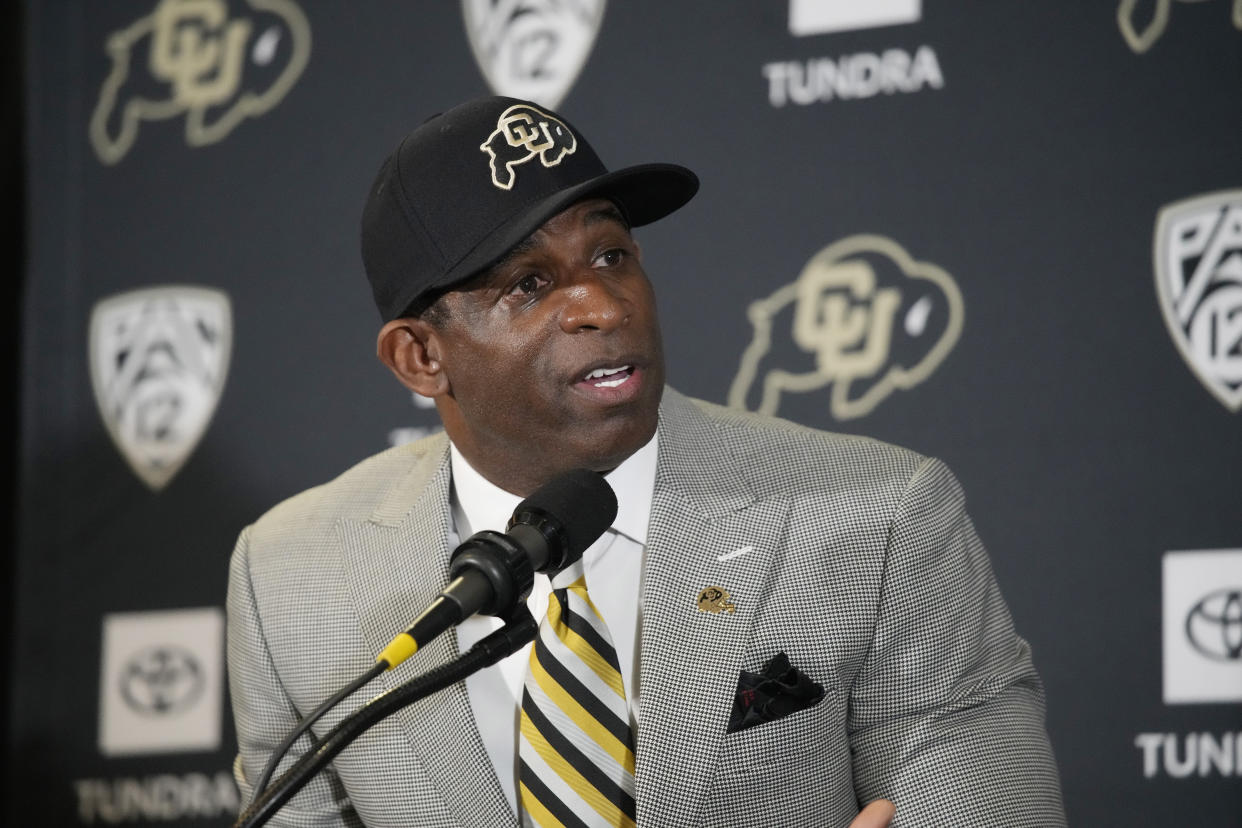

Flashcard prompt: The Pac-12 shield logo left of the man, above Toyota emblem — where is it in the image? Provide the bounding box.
[89,286,232,490]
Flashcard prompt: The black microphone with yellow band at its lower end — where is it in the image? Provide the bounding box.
[375,469,617,669]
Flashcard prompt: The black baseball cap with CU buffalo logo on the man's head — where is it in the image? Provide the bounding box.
[361,97,698,322]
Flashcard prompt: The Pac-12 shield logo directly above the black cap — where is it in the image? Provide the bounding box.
[462,0,604,109]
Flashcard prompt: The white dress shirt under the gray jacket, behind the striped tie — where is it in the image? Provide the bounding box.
[448,437,657,814]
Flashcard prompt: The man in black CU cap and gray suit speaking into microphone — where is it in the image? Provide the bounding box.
[229,98,1064,826]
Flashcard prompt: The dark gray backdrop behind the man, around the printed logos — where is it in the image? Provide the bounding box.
[9,0,1242,824]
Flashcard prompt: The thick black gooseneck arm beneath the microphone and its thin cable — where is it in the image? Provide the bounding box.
[233,615,539,828]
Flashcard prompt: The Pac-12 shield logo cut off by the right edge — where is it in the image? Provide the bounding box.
[1155,190,1242,411]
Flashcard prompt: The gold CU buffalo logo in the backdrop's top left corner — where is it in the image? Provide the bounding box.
[89,0,311,164]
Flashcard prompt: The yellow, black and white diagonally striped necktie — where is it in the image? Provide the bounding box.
[518,561,635,828]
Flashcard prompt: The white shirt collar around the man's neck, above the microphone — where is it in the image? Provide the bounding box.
[450,434,658,545]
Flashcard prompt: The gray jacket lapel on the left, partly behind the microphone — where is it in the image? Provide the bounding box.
[340,439,517,826]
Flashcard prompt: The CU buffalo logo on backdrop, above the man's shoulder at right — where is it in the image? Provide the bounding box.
[729,236,965,420]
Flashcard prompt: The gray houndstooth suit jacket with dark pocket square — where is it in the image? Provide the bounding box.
[229,390,1064,828]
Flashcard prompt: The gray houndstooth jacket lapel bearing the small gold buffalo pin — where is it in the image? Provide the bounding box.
[636,391,787,826]
